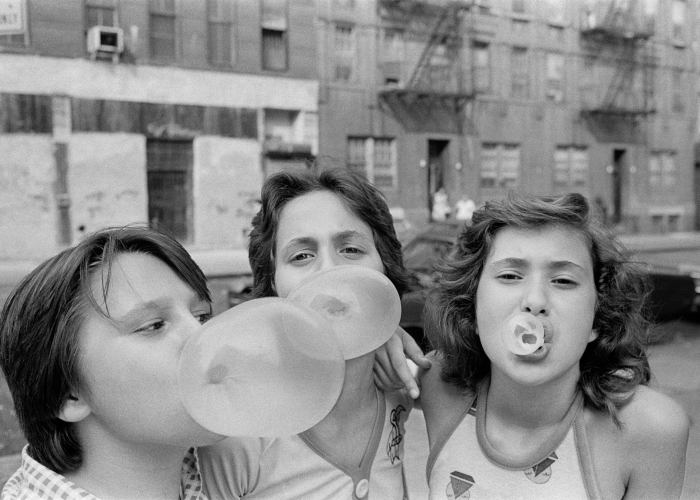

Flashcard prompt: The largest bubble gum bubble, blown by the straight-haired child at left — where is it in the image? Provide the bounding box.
[178,297,345,437]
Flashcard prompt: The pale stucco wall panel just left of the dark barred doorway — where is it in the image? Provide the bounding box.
[68,133,148,242]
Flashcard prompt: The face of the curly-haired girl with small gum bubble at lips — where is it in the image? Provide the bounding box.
[476,226,597,386]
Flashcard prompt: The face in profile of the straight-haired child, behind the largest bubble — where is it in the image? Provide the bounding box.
[78,253,217,446]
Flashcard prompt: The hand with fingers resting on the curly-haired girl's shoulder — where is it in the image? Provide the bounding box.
[374,327,431,399]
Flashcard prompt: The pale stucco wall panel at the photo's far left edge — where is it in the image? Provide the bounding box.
[0,134,58,259]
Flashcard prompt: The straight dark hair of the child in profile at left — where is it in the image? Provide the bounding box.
[0,226,211,473]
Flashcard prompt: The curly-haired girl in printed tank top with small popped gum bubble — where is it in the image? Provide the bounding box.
[421,194,689,499]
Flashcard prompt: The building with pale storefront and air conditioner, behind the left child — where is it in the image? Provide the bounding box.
[0,0,318,259]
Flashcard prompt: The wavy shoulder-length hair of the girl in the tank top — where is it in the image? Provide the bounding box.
[424,193,650,424]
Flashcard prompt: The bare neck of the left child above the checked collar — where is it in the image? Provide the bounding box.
[65,434,187,500]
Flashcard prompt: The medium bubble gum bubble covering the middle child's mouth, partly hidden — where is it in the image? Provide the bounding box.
[288,265,401,359]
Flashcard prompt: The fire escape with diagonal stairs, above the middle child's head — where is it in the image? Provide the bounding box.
[379,0,474,135]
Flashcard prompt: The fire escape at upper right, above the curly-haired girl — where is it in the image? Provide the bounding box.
[581,0,656,142]
